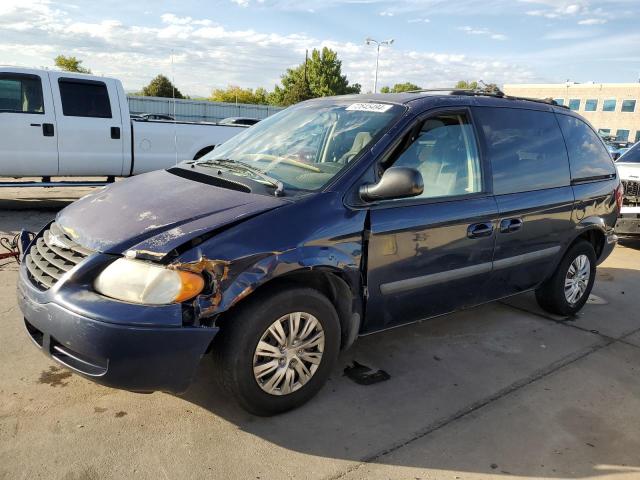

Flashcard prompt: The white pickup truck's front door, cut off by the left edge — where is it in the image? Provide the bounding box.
[0,69,58,177]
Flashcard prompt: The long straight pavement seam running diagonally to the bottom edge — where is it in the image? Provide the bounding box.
[326,338,617,480]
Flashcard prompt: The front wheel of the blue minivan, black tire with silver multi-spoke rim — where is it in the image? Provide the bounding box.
[213,287,340,416]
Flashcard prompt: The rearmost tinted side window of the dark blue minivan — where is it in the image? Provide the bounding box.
[556,114,616,181]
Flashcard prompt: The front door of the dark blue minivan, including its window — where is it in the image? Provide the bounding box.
[364,109,498,332]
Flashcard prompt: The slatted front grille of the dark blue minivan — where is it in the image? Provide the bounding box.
[24,222,93,290]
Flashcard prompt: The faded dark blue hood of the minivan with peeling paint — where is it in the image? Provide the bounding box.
[56,170,287,257]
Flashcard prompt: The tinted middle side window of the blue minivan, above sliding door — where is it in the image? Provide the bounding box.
[474,107,570,195]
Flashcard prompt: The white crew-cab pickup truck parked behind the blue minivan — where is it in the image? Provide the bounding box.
[0,67,246,186]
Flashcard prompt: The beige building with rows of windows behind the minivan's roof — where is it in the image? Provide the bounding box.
[503,82,640,142]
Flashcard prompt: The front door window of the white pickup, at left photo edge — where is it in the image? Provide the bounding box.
[0,73,44,114]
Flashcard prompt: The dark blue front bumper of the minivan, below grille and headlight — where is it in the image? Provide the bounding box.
[18,268,218,393]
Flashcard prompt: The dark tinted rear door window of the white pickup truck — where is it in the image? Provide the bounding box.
[58,78,111,118]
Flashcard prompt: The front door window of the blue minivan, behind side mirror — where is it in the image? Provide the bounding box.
[393,113,482,198]
